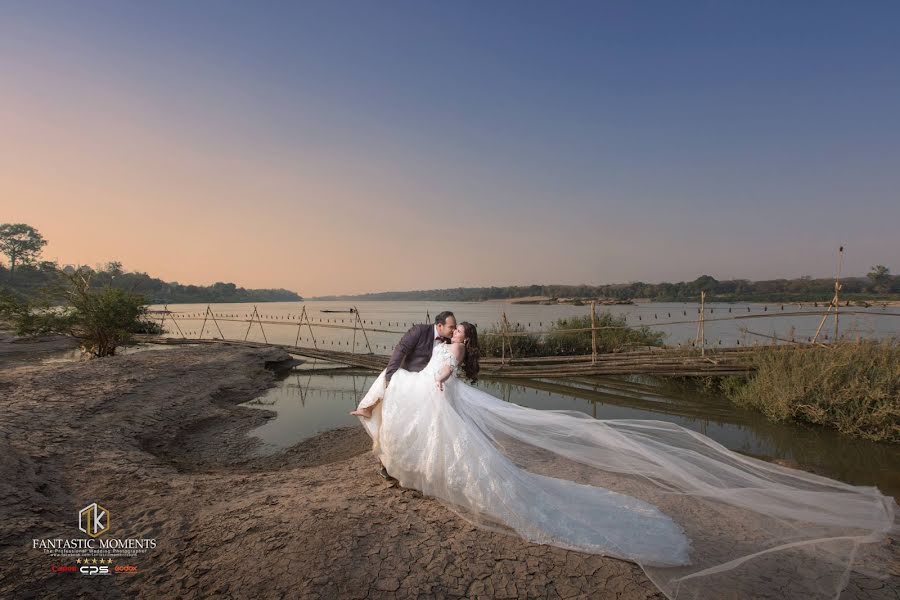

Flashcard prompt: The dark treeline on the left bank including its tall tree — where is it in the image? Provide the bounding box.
[0,223,303,304]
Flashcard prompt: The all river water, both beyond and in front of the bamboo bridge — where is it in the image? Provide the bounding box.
[146,302,900,497]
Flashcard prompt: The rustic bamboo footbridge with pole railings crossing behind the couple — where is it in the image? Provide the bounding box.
[137,280,900,379]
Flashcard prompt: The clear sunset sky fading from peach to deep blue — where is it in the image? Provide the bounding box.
[0,0,900,296]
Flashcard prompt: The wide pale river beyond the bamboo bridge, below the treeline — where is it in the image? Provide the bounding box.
[150,302,900,354]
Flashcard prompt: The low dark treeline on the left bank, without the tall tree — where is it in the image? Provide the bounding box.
[0,261,303,304]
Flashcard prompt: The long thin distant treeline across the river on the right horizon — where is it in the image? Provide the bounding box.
[315,272,900,302]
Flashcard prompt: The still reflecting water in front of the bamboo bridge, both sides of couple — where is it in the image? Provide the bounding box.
[244,361,900,496]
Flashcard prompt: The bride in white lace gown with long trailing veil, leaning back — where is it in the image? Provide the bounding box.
[353,322,897,598]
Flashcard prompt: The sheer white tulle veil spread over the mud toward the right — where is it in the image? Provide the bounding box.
[363,364,900,599]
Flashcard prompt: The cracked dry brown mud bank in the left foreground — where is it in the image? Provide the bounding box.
[0,346,896,599]
